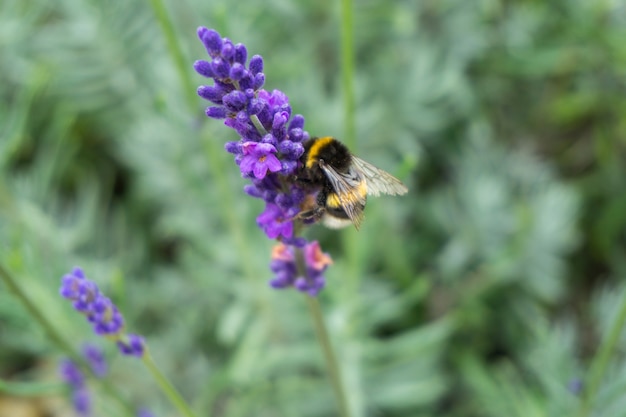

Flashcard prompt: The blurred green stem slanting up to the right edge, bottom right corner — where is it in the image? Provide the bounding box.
[578,293,626,417]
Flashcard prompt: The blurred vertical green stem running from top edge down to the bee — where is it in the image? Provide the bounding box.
[341,0,356,151]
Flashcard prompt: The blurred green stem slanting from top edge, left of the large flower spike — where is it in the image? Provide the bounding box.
[150,0,197,109]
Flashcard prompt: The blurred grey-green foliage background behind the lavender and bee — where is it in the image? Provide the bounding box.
[0,0,626,417]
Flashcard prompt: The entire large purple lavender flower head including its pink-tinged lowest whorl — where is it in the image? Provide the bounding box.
[194,27,332,296]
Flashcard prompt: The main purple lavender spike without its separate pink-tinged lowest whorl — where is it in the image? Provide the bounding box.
[194,27,309,239]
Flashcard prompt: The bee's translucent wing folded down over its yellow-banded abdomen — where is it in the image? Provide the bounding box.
[320,162,367,229]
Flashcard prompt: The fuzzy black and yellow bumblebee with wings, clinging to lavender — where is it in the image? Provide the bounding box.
[298,136,409,230]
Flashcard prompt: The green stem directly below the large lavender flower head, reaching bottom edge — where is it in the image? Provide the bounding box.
[306,295,350,417]
